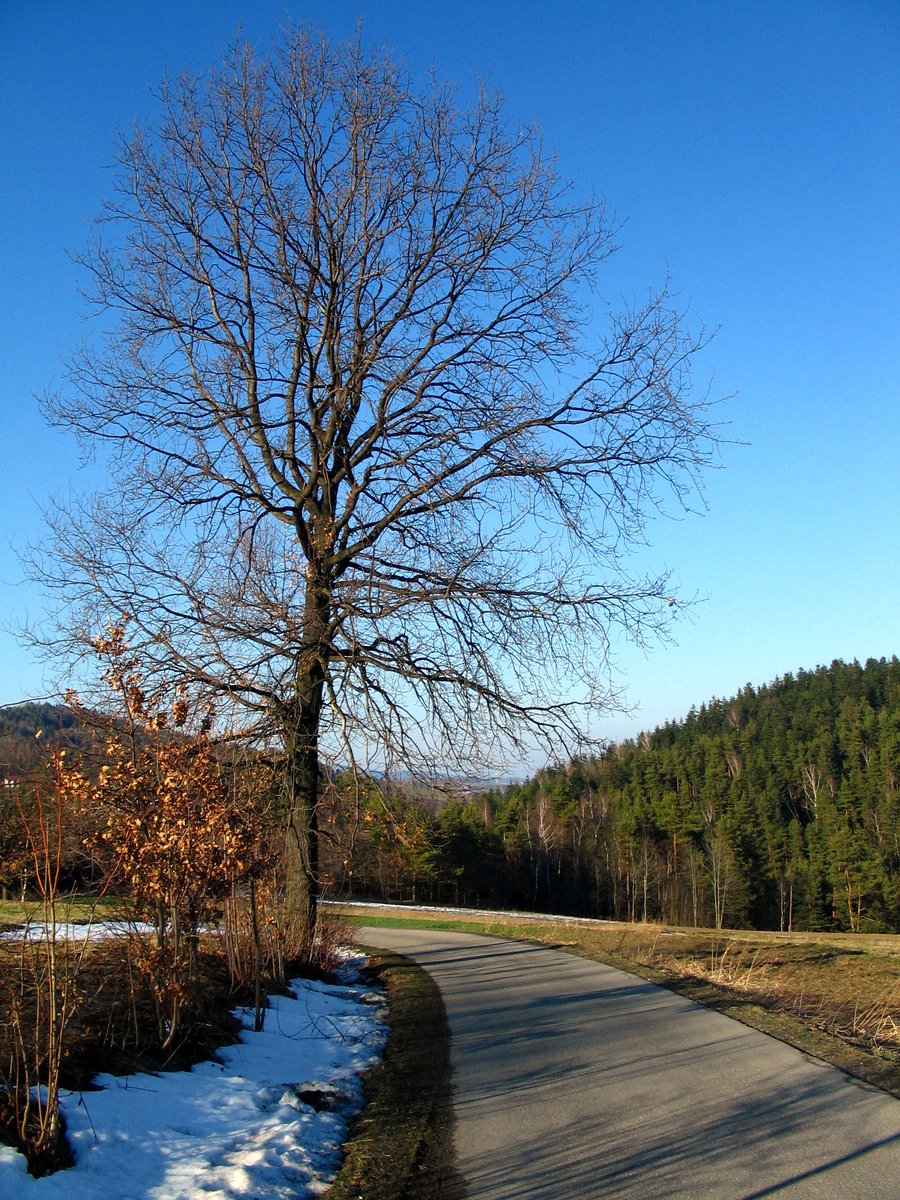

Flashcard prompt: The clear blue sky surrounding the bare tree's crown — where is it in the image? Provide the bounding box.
[0,0,900,737]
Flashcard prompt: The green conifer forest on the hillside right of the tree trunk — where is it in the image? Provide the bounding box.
[326,658,900,932]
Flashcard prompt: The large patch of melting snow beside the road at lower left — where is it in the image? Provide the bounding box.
[0,960,388,1200]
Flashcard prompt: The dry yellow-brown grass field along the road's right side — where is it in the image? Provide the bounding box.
[340,906,900,1097]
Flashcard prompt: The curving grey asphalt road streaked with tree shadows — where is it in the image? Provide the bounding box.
[360,928,900,1200]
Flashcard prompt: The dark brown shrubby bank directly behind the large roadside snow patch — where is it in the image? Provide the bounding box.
[0,922,347,1176]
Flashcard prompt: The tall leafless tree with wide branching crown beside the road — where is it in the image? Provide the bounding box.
[33,29,715,940]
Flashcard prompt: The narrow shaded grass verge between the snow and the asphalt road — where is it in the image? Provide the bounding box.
[325,950,455,1200]
